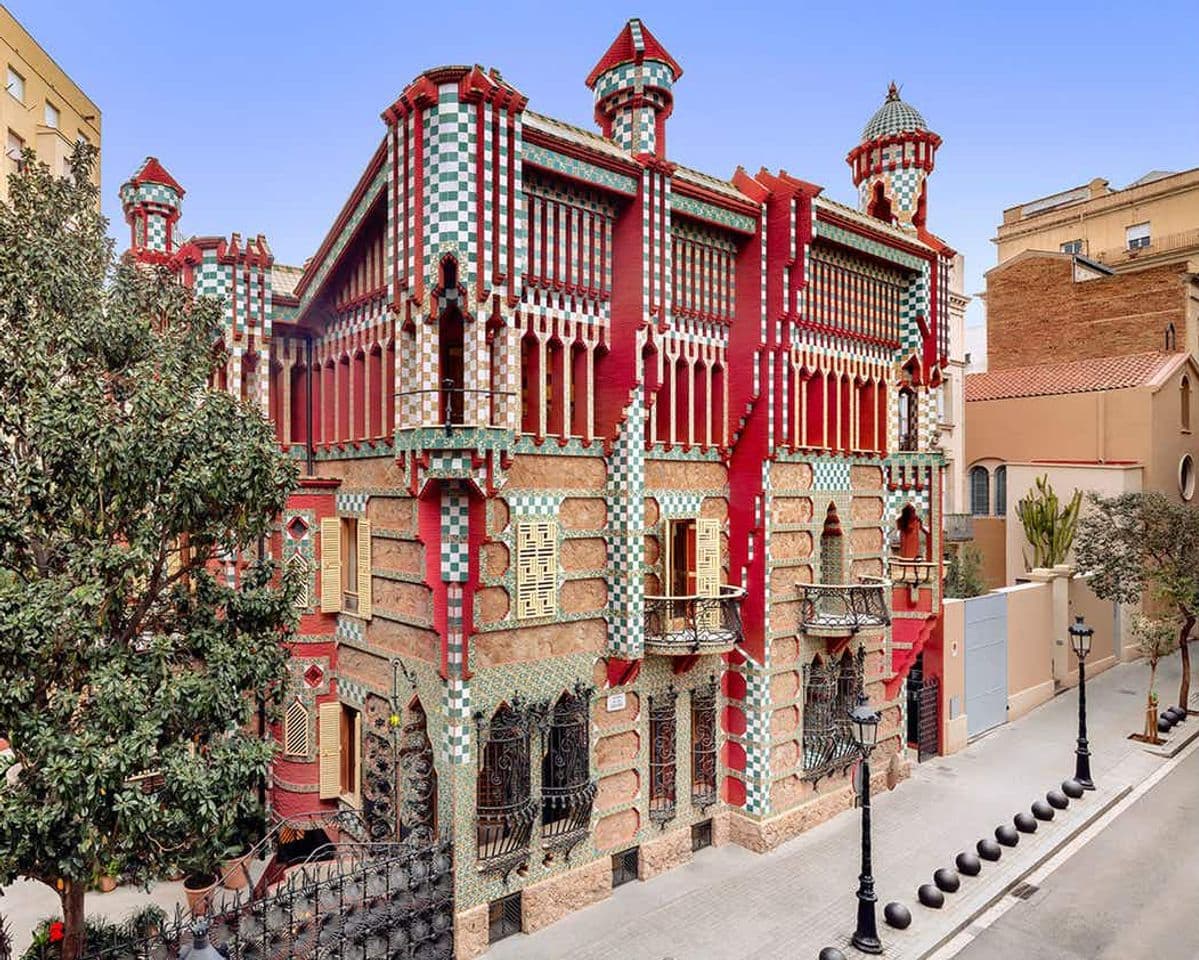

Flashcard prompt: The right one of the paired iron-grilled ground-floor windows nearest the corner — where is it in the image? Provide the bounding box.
[541,690,596,851]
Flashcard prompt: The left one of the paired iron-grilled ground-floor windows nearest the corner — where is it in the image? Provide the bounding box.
[475,704,537,869]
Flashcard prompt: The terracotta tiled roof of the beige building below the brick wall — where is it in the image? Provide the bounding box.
[966,352,1186,403]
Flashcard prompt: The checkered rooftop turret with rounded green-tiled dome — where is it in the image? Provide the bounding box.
[845,83,941,233]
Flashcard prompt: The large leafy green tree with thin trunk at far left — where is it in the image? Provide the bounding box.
[0,146,295,960]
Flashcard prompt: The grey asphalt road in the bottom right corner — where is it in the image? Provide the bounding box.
[957,743,1199,960]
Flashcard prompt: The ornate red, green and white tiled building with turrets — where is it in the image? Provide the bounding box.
[122,20,953,956]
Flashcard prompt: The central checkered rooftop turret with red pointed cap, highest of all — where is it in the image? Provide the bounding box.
[586,18,682,158]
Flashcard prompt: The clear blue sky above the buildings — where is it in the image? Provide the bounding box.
[5,0,1199,325]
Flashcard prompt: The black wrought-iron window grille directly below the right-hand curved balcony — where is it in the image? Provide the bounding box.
[803,647,866,780]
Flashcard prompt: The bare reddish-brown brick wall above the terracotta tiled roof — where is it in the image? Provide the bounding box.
[987,256,1186,370]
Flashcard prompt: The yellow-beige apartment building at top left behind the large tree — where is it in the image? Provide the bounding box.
[0,5,100,200]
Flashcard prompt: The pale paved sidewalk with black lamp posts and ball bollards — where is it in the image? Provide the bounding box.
[487,658,1199,960]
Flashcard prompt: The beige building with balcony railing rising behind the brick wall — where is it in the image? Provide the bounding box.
[995,168,1199,272]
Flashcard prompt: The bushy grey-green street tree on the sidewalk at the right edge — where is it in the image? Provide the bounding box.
[1076,493,1199,710]
